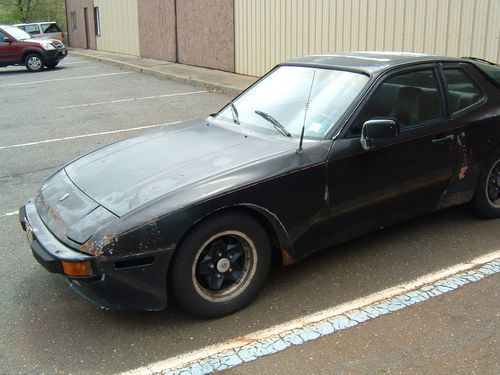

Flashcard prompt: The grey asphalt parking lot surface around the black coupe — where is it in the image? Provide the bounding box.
[0,55,500,374]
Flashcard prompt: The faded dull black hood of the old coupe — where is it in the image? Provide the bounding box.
[65,119,297,217]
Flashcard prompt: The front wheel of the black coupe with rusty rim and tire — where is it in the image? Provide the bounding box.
[169,213,271,318]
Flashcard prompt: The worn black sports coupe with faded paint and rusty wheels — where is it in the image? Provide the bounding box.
[19,52,500,317]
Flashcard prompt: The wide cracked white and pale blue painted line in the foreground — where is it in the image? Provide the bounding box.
[123,251,500,375]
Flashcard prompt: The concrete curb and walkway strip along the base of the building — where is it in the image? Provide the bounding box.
[69,49,252,95]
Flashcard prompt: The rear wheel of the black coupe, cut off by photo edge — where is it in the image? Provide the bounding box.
[472,148,500,219]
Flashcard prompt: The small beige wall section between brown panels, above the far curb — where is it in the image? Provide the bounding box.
[94,0,140,56]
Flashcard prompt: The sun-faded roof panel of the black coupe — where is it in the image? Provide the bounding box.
[280,51,466,75]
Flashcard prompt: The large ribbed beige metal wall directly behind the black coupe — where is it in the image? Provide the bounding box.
[235,0,500,76]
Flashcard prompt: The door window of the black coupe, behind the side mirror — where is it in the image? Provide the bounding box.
[348,69,443,137]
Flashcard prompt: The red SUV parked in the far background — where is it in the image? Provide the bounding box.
[0,25,67,72]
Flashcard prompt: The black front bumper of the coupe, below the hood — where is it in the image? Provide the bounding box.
[19,201,173,310]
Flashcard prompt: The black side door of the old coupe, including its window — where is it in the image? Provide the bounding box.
[328,65,459,238]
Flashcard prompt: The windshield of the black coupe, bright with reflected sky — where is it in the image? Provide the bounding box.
[217,66,369,139]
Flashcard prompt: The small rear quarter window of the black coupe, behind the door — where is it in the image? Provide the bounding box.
[443,68,482,113]
